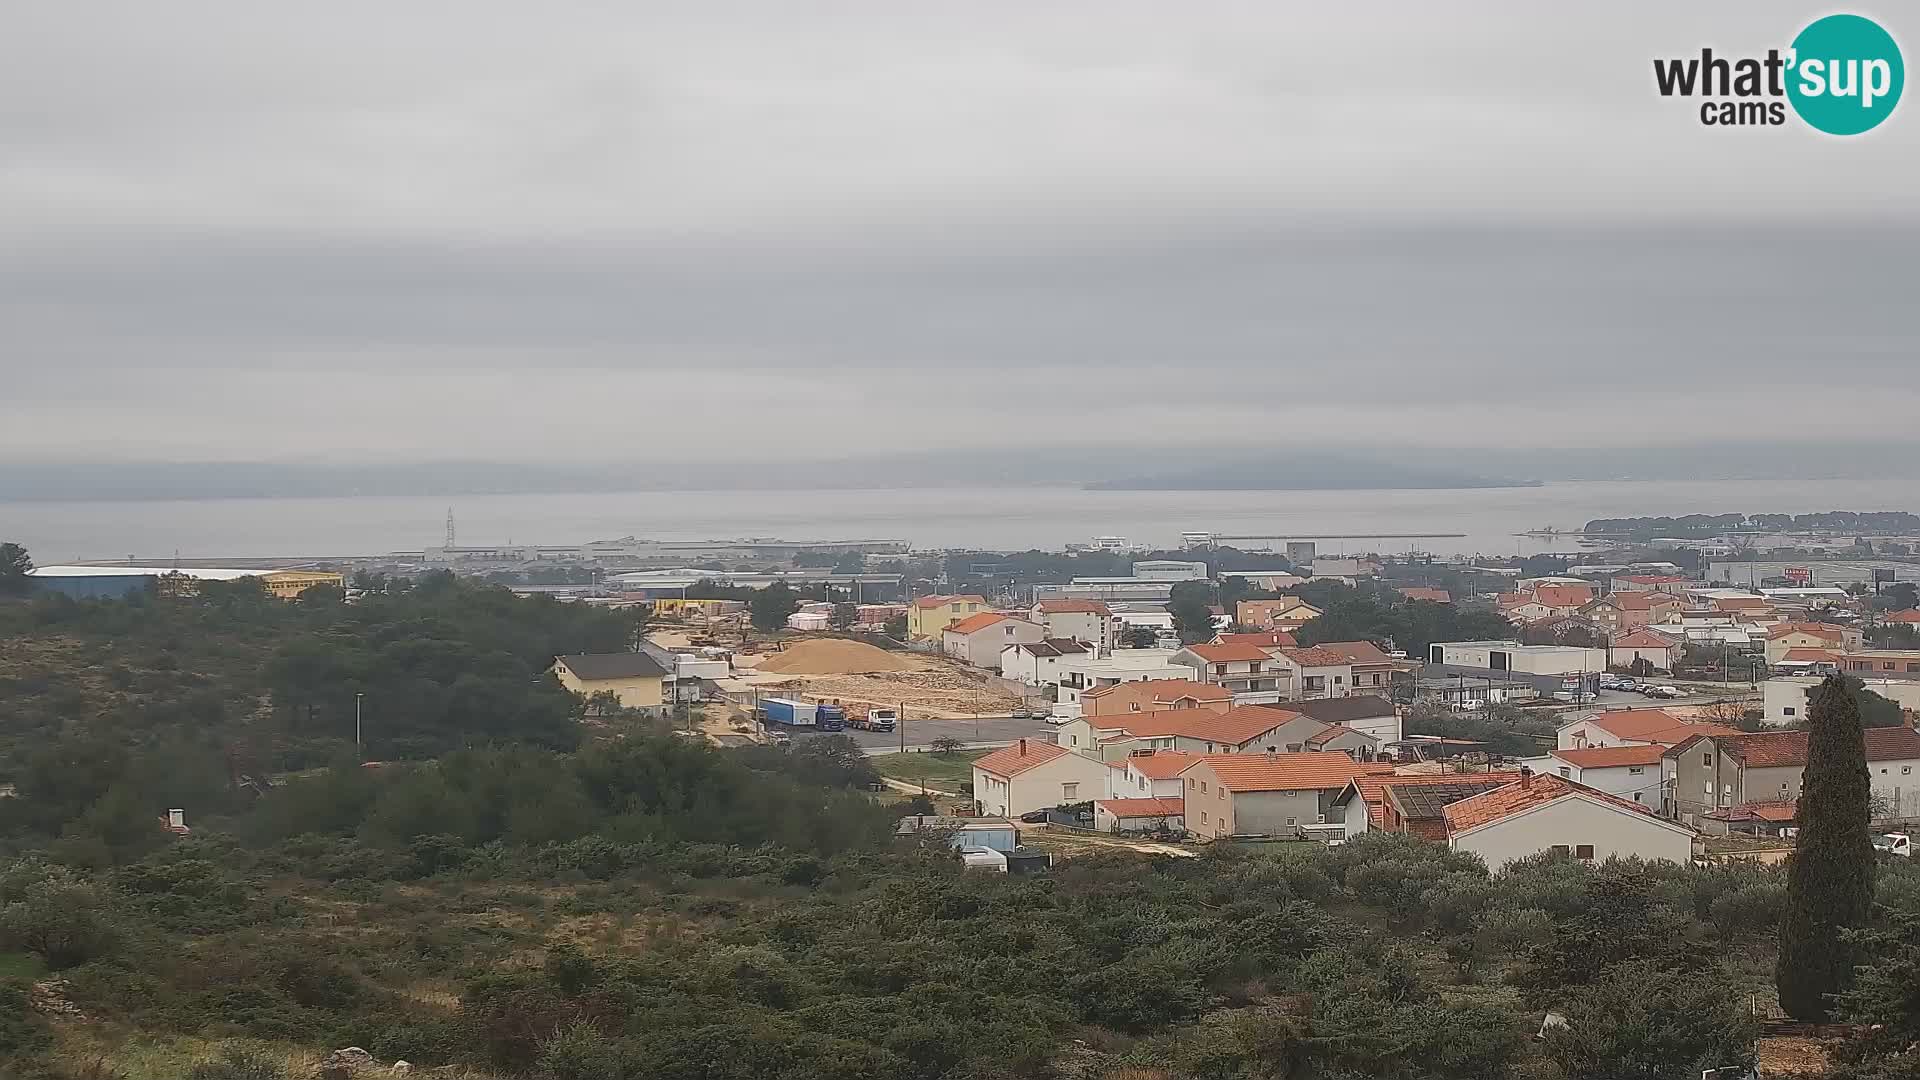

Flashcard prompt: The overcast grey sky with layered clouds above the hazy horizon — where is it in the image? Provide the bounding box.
[0,0,1920,461]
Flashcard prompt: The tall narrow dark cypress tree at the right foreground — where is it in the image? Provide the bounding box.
[1774,675,1874,1022]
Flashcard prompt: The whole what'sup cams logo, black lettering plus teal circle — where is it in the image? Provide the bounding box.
[1653,15,1907,135]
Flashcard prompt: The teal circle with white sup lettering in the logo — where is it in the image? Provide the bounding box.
[1788,15,1907,135]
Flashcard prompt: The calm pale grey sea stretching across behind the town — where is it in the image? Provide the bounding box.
[0,477,1920,563]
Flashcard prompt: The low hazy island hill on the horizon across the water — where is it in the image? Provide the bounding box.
[1087,454,1540,492]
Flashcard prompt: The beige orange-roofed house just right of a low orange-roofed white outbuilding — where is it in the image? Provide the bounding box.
[1181,753,1394,836]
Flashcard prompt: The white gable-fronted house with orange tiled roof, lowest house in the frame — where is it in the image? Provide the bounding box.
[1442,774,1693,871]
